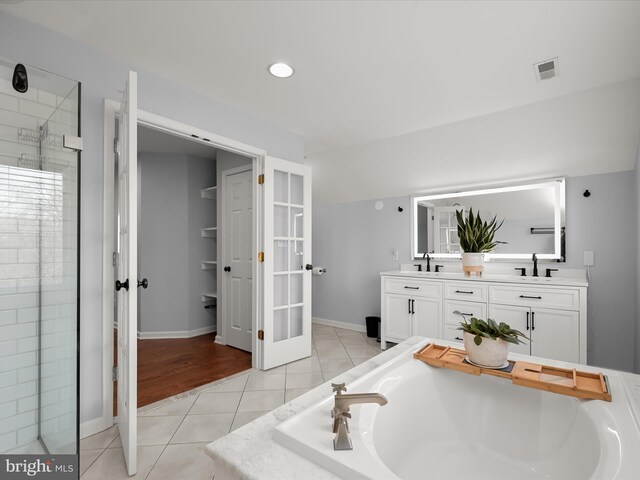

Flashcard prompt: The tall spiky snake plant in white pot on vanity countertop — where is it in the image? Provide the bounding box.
[456,208,505,276]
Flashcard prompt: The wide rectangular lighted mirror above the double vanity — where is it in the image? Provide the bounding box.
[412,178,565,261]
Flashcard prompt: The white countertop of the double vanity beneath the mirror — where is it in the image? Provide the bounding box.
[380,269,589,287]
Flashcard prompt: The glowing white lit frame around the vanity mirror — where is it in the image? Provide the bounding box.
[411,177,565,262]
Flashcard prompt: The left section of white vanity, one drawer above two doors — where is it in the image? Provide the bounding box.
[381,277,442,349]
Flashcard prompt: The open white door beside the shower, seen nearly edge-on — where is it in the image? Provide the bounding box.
[116,72,138,475]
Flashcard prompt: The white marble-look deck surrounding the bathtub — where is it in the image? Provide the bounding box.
[206,337,640,480]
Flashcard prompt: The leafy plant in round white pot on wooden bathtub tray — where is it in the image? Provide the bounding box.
[458,318,529,368]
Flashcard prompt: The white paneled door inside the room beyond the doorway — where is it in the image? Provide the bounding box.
[222,169,254,352]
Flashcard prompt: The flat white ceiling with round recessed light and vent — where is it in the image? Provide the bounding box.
[0,1,640,155]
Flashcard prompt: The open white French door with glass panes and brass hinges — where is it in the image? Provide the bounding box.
[262,157,311,369]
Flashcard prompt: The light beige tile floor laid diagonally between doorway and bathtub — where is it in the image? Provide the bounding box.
[80,324,381,480]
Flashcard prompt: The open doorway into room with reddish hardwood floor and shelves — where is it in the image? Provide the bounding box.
[114,125,253,414]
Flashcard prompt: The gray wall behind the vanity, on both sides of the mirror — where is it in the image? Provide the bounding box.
[313,172,637,371]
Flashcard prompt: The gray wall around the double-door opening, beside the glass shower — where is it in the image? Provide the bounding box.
[0,13,304,422]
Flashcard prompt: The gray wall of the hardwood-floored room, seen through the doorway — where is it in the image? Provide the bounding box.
[138,153,216,333]
